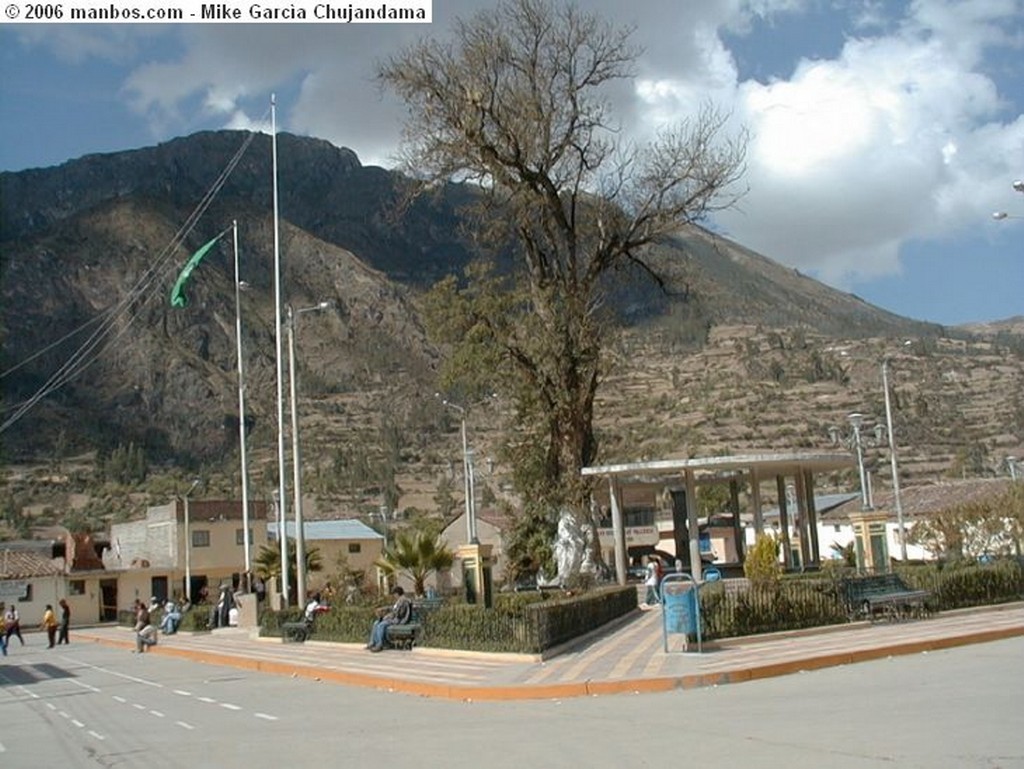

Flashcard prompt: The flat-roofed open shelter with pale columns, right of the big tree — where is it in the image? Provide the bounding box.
[582,452,856,584]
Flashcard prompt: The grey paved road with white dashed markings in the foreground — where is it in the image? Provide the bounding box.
[0,638,1024,769]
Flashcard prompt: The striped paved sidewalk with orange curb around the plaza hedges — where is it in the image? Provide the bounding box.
[73,603,1024,700]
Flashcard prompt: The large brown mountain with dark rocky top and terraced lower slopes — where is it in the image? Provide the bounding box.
[0,131,1024,518]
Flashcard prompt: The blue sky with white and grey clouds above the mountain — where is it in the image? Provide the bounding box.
[0,0,1024,325]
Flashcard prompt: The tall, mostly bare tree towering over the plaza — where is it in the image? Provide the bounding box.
[378,0,745,514]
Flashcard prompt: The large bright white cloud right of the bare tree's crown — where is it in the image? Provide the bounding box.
[708,2,1024,287]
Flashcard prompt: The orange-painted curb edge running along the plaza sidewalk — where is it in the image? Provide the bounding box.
[78,627,1024,702]
